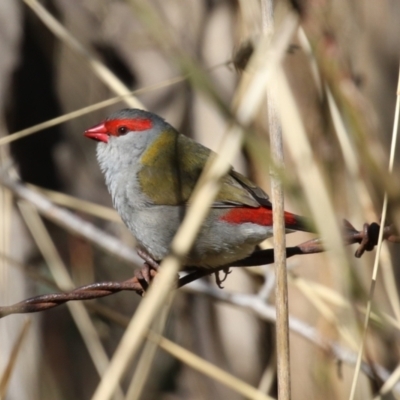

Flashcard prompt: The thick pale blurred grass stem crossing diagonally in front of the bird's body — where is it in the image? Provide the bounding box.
[92,12,296,400]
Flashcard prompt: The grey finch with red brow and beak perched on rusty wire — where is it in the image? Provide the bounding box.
[85,109,309,268]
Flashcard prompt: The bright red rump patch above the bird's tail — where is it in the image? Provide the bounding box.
[220,207,297,227]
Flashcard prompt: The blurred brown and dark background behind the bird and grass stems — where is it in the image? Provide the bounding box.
[0,0,400,400]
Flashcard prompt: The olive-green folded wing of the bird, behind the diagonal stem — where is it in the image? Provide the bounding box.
[138,128,270,207]
